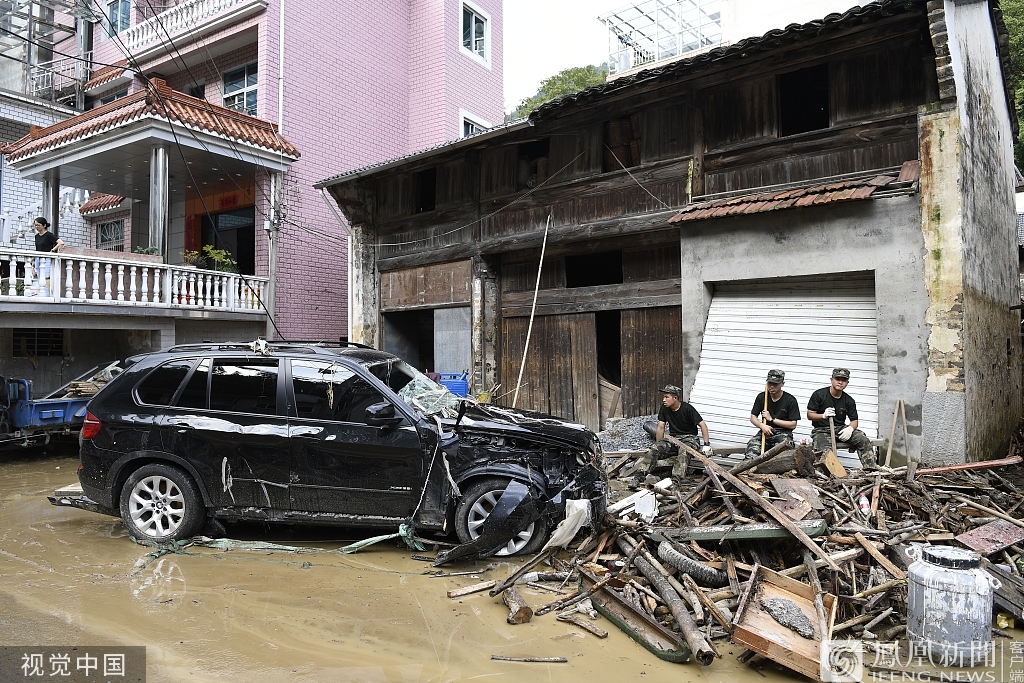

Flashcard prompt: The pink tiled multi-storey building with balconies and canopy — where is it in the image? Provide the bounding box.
[0,0,503,374]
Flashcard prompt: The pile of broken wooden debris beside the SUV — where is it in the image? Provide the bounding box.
[444,432,1024,680]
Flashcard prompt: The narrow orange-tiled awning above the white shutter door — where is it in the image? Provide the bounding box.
[669,172,916,223]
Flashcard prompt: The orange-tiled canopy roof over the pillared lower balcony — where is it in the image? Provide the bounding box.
[0,78,299,162]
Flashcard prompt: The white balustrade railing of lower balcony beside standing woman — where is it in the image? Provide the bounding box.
[0,248,267,312]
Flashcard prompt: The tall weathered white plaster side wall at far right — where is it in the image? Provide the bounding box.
[945,0,1021,461]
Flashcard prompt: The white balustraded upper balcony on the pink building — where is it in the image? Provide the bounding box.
[119,0,266,61]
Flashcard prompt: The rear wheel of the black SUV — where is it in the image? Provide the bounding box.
[121,464,206,543]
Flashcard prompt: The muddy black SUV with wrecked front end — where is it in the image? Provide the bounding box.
[79,341,605,554]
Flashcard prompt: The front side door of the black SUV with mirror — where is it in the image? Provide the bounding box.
[289,359,425,517]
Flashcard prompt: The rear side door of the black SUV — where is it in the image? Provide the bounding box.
[165,357,291,510]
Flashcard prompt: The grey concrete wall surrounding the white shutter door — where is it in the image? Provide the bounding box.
[681,196,933,464]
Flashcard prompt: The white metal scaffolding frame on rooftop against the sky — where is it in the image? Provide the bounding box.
[598,0,722,76]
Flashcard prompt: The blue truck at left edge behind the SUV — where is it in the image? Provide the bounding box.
[0,362,120,451]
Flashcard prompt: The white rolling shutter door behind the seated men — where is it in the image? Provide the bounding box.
[689,274,879,467]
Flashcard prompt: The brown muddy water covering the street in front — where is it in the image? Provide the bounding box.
[0,456,1015,683]
